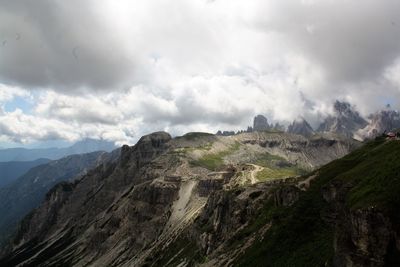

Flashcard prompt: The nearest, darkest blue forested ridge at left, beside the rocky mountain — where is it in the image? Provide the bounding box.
[0,150,119,247]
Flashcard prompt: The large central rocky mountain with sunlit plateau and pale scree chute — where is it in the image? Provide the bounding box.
[0,132,359,266]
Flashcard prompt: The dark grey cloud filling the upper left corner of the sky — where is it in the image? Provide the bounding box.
[0,0,133,90]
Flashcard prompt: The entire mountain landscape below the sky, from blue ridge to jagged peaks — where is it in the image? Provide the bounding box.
[0,102,400,267]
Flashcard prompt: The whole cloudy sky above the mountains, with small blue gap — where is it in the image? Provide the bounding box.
[0,0,400,146]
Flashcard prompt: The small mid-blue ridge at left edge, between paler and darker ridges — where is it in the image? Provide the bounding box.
[0,159,50,187]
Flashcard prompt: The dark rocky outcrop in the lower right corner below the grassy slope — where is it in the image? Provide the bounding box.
[322,177,400,267]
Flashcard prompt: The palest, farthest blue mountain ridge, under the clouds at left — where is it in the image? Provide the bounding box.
[0,139,116,162]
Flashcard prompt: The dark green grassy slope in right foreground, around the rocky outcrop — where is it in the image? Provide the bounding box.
[236,139,400,266]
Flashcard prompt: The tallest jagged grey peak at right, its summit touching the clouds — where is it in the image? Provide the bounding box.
[317,100,368,137]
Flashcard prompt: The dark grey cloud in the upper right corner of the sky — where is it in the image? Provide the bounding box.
[261,0,400,83]
